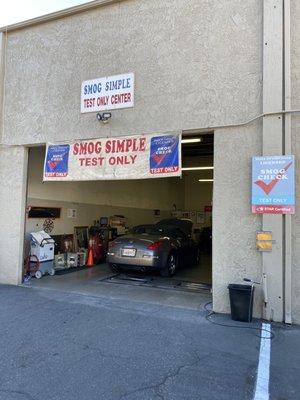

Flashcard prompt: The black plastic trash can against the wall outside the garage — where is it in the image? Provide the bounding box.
[228,284,254,322]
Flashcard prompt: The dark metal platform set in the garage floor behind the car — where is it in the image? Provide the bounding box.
[100,274,211,292]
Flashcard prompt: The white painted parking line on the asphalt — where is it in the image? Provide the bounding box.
[254,323,271,400]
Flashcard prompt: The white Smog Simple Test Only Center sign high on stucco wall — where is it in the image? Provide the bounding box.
[81,73,134,113]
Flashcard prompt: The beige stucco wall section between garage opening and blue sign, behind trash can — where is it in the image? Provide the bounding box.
[213,122,262,316]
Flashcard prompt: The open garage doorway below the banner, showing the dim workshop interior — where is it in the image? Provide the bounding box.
[25,134,214,290]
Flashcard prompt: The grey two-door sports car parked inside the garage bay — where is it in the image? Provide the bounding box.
[107,218,199,276]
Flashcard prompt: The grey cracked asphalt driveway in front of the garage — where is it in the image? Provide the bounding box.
[0,286,300,400]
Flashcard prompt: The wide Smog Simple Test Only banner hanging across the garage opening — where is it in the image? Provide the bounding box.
[44,134,181,181]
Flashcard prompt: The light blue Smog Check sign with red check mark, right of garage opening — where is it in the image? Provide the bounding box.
[252,156,295,214]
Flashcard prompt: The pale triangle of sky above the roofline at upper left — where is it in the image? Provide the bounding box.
[0,0,88,27]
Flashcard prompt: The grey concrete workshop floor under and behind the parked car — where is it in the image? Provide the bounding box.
[23,257,211,309]
